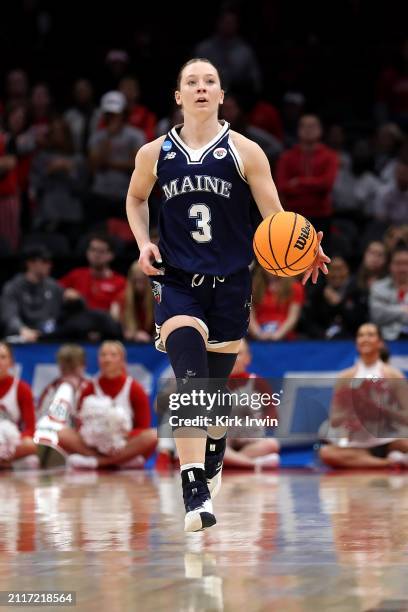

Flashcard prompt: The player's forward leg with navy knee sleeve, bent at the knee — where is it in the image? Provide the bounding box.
[160,315,216,531]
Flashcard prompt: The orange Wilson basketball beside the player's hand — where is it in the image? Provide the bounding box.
[253,211,318,277]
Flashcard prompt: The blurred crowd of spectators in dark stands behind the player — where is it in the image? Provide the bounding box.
[0,0,408,342]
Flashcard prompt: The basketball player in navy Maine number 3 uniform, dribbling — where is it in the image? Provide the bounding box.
[126,59,330,531]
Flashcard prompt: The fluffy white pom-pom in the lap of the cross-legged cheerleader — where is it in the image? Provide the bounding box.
[79,395,132,455]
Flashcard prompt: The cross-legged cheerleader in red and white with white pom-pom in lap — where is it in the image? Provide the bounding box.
[58,342,157,469]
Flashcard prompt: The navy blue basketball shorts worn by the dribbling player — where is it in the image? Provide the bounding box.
[150,266,252,352]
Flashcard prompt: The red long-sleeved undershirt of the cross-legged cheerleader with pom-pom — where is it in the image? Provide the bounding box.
[78,374,151,430]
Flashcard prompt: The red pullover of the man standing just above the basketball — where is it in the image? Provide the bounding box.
[276,144,338,217]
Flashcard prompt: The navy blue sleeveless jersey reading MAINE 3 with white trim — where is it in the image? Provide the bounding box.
[156,122,253,276]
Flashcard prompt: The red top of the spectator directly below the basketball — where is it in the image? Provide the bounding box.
[254,281,305,340]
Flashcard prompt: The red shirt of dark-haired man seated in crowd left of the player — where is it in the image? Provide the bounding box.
[59,268,126,311]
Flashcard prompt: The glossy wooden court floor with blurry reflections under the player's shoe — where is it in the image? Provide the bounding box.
[0,471,408,612]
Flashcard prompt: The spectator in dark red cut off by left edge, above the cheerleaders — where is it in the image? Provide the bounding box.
[0,126,20,251]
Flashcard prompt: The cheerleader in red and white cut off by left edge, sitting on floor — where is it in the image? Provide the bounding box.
[0,342,39,469]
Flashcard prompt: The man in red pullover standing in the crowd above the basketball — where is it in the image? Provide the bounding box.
[276,115,338,238]
